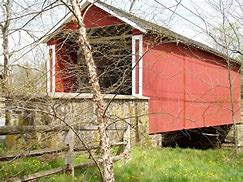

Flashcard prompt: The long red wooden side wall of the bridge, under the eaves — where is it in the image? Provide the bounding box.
[143,37,240,133]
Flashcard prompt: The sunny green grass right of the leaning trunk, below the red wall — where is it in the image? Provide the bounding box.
[116,148,243,182]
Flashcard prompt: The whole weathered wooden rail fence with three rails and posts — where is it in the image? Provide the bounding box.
[0,124,130,181]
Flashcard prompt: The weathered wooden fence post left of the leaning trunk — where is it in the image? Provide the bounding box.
[64,128,74,176]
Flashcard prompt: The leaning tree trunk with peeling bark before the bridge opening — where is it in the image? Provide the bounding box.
[70,0,114,182]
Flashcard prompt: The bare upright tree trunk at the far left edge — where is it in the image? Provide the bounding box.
[0,0,11,93]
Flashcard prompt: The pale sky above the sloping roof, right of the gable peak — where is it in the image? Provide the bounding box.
[107,0,214,44]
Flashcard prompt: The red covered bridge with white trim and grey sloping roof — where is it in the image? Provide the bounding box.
[44,1,240,134]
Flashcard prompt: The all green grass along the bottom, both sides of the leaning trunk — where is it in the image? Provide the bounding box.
[0,147,243,182]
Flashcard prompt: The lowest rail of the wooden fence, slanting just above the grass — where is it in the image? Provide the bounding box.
[9,156,121,182]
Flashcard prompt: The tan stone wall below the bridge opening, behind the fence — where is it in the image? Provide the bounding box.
[5,93,149,149]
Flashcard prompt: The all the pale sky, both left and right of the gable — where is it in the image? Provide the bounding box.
[0,0,242,63]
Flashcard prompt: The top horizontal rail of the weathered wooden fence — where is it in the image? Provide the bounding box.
[0,125,125,135]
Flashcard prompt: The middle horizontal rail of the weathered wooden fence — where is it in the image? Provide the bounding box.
[0,142,126,161]
